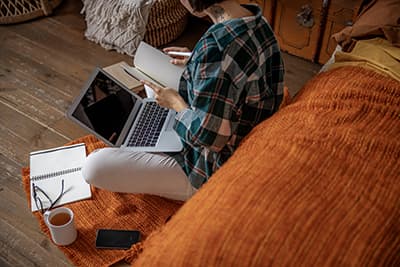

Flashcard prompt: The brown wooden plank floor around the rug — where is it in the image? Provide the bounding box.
[0,0,319,266]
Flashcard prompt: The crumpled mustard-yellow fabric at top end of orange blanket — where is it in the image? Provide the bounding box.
[330,38,400,81]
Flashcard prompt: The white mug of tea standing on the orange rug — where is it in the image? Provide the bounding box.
[44,207,78,246]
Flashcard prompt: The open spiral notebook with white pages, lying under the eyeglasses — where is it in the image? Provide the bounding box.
[30,144,92,211]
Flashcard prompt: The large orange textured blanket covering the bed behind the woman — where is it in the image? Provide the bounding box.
[134,67,400,267]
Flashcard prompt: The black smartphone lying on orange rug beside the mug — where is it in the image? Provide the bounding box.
[96,229,140,249]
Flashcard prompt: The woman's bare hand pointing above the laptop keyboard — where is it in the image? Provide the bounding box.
[140,80,188,112]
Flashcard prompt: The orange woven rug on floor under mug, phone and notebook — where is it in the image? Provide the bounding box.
[22,135,182,266]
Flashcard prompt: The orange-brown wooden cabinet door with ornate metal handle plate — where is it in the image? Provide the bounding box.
[274,0,323,61]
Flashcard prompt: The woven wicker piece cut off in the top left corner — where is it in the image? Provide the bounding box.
[0,0,62,24]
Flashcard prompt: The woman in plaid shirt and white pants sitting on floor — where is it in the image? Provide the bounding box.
[83,0,284,200]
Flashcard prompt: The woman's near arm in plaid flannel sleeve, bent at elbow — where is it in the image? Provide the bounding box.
[175,46,238,152]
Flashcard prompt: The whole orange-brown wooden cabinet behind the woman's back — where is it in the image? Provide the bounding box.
[260,0,362,64]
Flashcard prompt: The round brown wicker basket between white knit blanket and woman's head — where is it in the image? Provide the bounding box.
[144,0,189,47]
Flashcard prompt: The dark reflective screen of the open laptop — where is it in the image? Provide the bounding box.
[72,72,136,144]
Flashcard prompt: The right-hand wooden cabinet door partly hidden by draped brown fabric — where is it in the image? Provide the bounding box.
[318,0,362,64]
